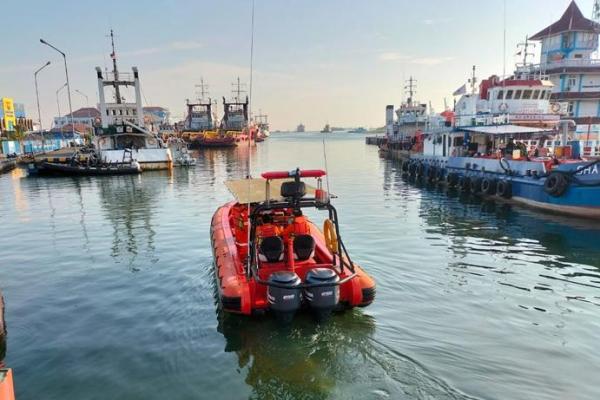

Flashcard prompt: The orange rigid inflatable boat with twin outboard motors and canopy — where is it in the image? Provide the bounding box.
[211,169,375,322]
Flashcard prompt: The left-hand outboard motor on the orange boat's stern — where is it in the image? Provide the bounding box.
[267,271,302,323]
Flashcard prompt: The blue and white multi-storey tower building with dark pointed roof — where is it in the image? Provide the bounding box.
[522,1,600,133]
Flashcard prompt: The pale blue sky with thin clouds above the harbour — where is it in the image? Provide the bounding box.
[0,0,592,130]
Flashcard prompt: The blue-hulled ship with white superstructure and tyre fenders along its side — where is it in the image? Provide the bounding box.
[386,58,600,218]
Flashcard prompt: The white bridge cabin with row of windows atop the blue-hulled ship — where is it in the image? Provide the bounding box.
[455,75,560,127]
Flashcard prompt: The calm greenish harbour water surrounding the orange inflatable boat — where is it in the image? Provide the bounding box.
[0,134,600,400]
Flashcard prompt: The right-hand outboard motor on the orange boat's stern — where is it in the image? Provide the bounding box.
[304,268,340,321]
